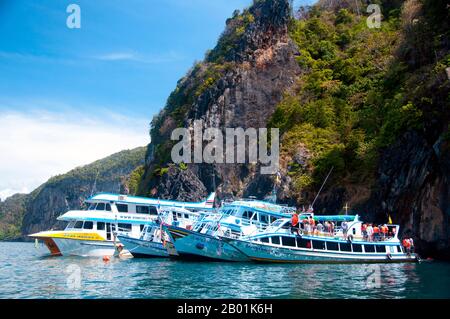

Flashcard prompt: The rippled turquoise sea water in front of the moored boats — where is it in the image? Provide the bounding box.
[0,242,450,299]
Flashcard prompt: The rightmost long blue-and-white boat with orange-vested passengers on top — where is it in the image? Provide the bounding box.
[222,214,418,263]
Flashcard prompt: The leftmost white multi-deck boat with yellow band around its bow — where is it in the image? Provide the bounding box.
[28,193,215,256]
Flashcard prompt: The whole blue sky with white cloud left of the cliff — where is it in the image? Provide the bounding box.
[0,0,314,199]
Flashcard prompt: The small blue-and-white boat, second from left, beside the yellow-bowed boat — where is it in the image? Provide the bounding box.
[117,207,200,258]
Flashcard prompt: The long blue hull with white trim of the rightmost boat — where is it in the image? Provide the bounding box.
[224,238,417,263]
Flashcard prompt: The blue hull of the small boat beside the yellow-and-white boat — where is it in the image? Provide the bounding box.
[118,235,178,258]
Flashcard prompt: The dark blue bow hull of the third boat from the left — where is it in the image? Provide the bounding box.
[166,226,249,261]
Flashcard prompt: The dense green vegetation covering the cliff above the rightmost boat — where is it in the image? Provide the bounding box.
[269,0,449,192]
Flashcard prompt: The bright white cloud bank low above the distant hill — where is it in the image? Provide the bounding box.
[0,110,149,199]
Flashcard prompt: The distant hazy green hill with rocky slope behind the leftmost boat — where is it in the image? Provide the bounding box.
[0,147,146,239]
